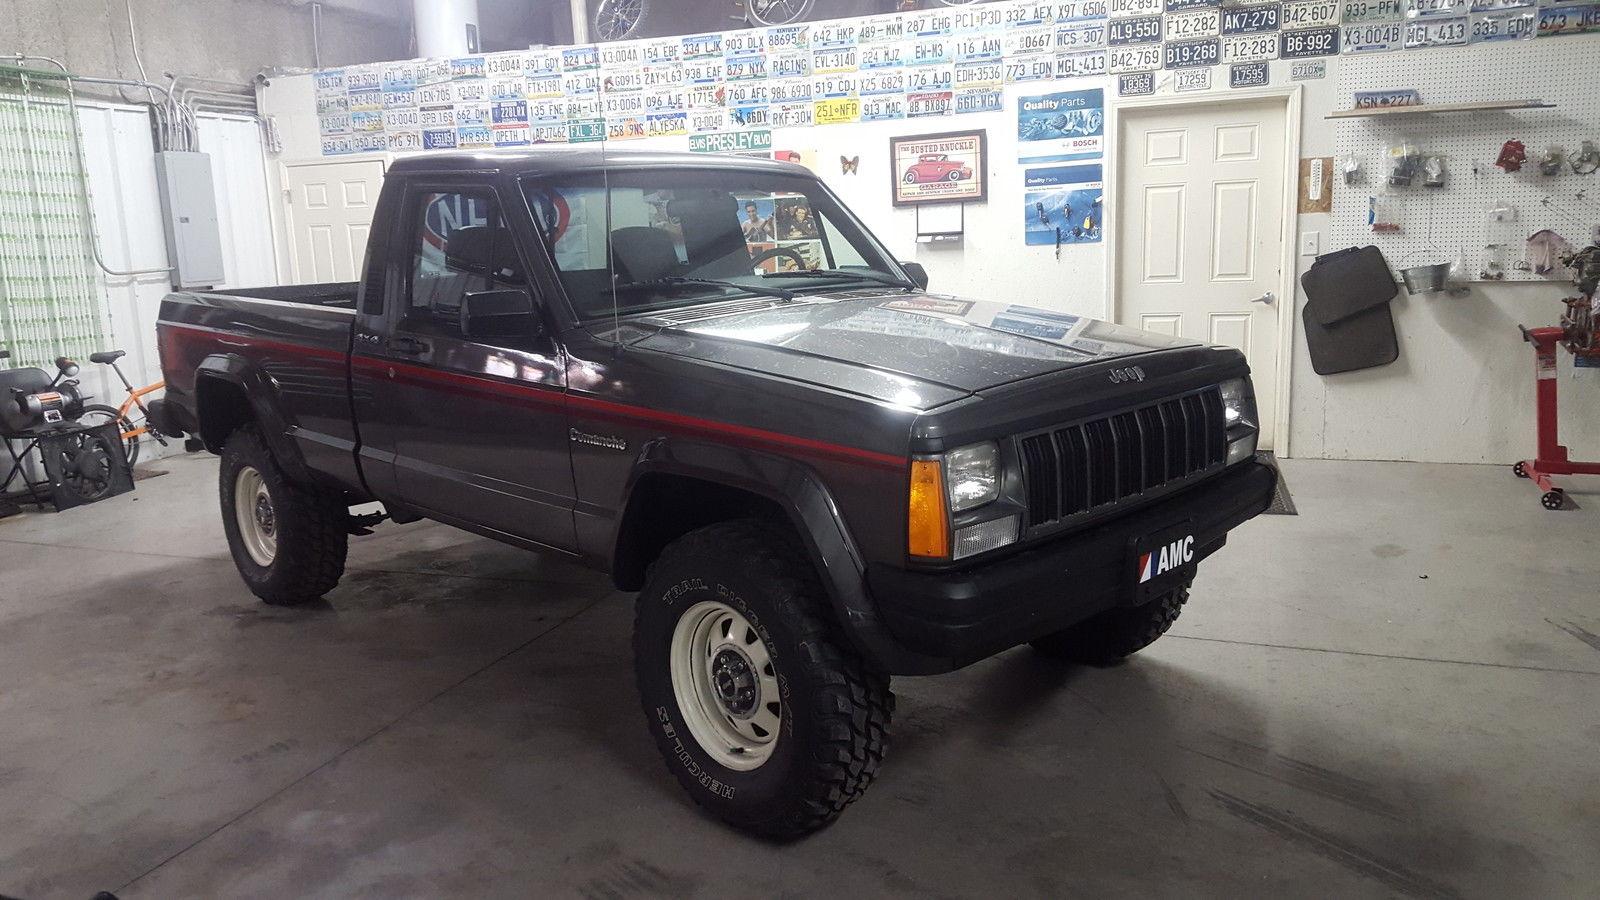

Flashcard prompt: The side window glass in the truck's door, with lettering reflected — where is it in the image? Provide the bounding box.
[405,191,526,336]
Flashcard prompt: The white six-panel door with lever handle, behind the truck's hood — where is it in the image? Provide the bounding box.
[1115,98,1290,448]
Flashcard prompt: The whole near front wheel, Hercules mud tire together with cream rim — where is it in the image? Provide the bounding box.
[634,520,894,839]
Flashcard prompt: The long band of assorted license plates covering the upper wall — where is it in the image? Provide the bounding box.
[305,0,1600,155]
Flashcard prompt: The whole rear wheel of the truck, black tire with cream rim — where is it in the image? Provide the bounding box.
[218,424,350,605]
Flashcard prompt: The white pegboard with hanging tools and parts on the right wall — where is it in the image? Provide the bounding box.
[1331,37,1600,282]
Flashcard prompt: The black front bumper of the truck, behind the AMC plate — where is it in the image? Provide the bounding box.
[867,461,1277,674]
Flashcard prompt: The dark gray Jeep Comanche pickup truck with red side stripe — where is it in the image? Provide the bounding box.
[152,147,1274,836]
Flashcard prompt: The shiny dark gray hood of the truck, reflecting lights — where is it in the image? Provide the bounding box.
[624,291,1198,408]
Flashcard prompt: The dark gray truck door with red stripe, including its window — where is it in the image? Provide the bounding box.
[376,181,576,551]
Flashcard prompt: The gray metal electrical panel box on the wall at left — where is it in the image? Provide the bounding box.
[155,151,227,290]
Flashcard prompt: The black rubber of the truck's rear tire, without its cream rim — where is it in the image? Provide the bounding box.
[218,424,350,607]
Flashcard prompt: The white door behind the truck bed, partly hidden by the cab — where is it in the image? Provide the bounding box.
[283,160,384,285]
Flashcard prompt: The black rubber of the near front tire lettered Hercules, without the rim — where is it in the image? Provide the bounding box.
[634,520,894,839]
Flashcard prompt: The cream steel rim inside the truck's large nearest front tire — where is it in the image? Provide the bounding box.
[669,601,782,772]
